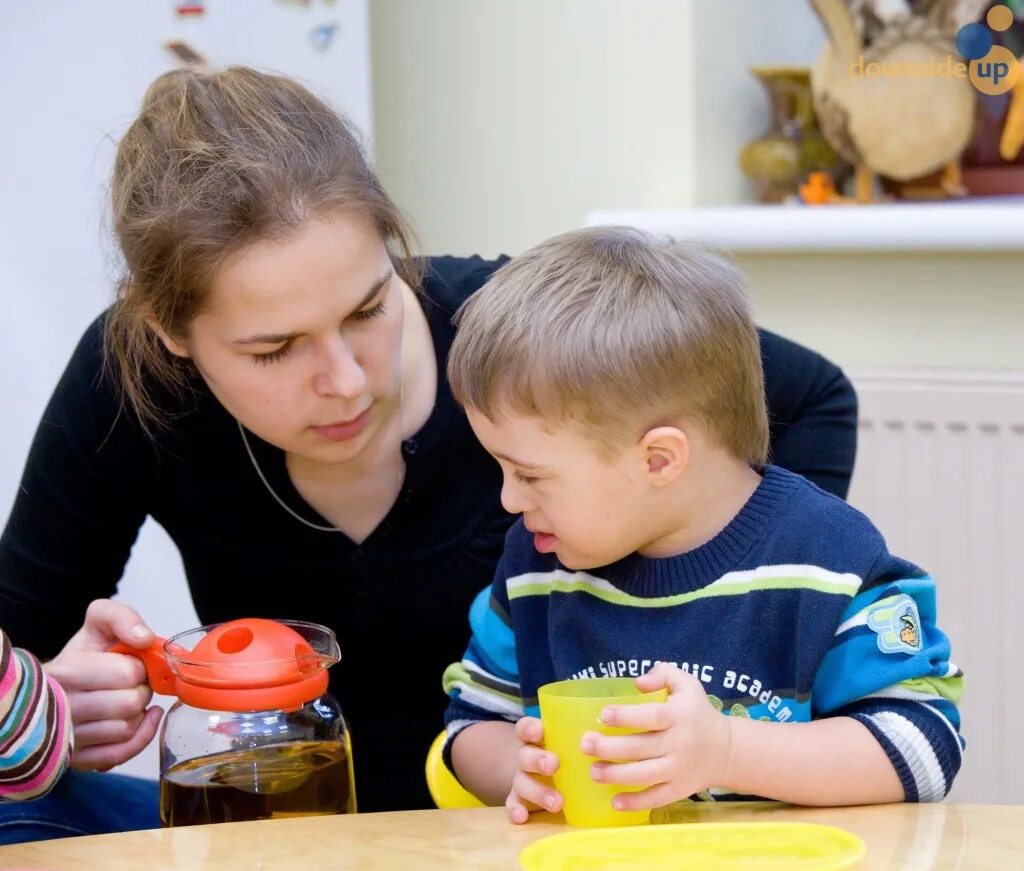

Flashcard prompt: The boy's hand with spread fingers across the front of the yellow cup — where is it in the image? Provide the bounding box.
[582,662,731,811]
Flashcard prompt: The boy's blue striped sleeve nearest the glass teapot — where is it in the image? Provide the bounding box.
[443,563,524,769]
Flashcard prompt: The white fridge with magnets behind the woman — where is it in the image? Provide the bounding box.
[0,0,372,776]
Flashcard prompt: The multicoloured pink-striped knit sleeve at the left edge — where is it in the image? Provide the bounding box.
[0,632,72,800]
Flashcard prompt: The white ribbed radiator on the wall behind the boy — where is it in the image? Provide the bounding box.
[850,371,1024,803]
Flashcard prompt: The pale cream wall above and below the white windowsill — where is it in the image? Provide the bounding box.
[371,0,1024,369]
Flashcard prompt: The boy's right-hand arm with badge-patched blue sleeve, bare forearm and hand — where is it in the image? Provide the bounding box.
[585,554,964,810]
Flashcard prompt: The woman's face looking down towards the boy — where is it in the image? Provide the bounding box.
[172,215,404,463]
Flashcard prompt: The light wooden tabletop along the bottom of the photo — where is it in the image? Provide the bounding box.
[0,803,1024,871]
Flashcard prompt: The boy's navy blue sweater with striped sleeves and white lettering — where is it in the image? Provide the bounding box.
[444,466,964,801]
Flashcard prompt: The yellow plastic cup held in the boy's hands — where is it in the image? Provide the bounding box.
[538,678,669,826]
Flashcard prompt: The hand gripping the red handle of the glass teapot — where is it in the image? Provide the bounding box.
[44,599,164,771]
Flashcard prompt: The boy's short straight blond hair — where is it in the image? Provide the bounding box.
[447,227,768,466]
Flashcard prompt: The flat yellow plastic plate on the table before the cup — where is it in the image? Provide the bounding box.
[519,823,867,871]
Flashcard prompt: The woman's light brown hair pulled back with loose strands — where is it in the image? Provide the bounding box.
[104,67,420,431]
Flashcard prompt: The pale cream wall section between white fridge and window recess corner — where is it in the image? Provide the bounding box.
[371,0,694,256]
